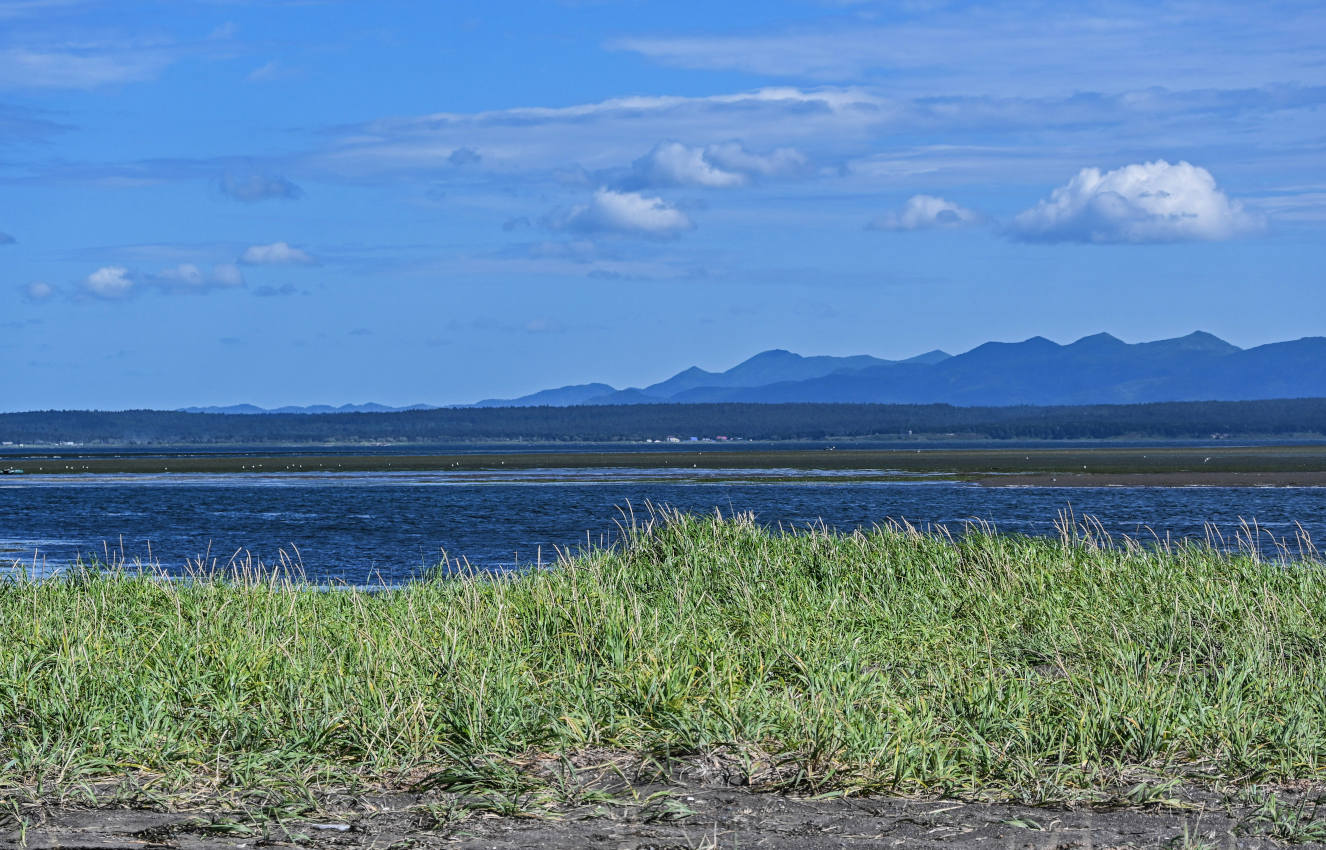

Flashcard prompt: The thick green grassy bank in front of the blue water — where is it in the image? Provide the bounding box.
[0,516,1326,800]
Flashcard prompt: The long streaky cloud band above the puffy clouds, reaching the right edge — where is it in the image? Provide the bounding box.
[300,79,1326,196]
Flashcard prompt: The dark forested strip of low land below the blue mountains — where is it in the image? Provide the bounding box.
[0,398,1326,446]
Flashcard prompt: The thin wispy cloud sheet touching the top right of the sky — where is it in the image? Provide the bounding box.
[607,0,1326,94]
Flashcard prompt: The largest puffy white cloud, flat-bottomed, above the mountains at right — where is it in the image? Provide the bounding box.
[1009,159,1264,243]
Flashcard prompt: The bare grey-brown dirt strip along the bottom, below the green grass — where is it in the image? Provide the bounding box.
[10,785,1326,850]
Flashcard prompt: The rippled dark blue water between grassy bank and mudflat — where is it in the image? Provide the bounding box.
[0,469,1326,583]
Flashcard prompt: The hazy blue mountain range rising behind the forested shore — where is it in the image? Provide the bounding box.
[476,330,1326,407]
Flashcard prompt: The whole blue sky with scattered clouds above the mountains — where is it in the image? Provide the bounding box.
[0,0,1326,410]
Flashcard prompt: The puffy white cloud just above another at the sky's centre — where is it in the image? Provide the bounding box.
[627,142,806,188]
